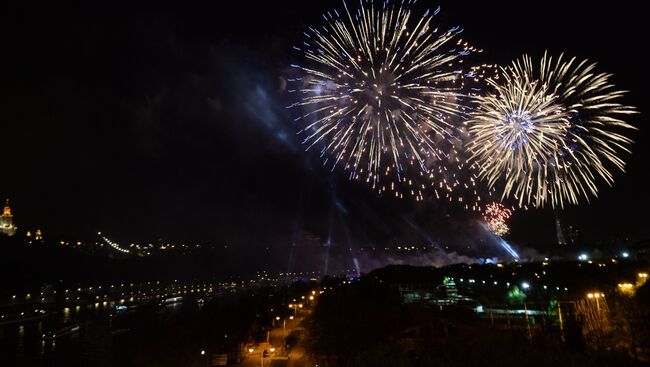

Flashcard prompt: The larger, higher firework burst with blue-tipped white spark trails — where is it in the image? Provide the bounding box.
[289,1,476,200]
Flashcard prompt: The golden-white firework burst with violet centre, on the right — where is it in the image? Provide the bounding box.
[466,54,636,207]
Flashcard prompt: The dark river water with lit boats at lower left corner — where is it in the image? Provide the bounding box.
[0,302,194,367]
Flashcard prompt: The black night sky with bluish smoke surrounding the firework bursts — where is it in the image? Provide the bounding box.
[0,0,650,256]
